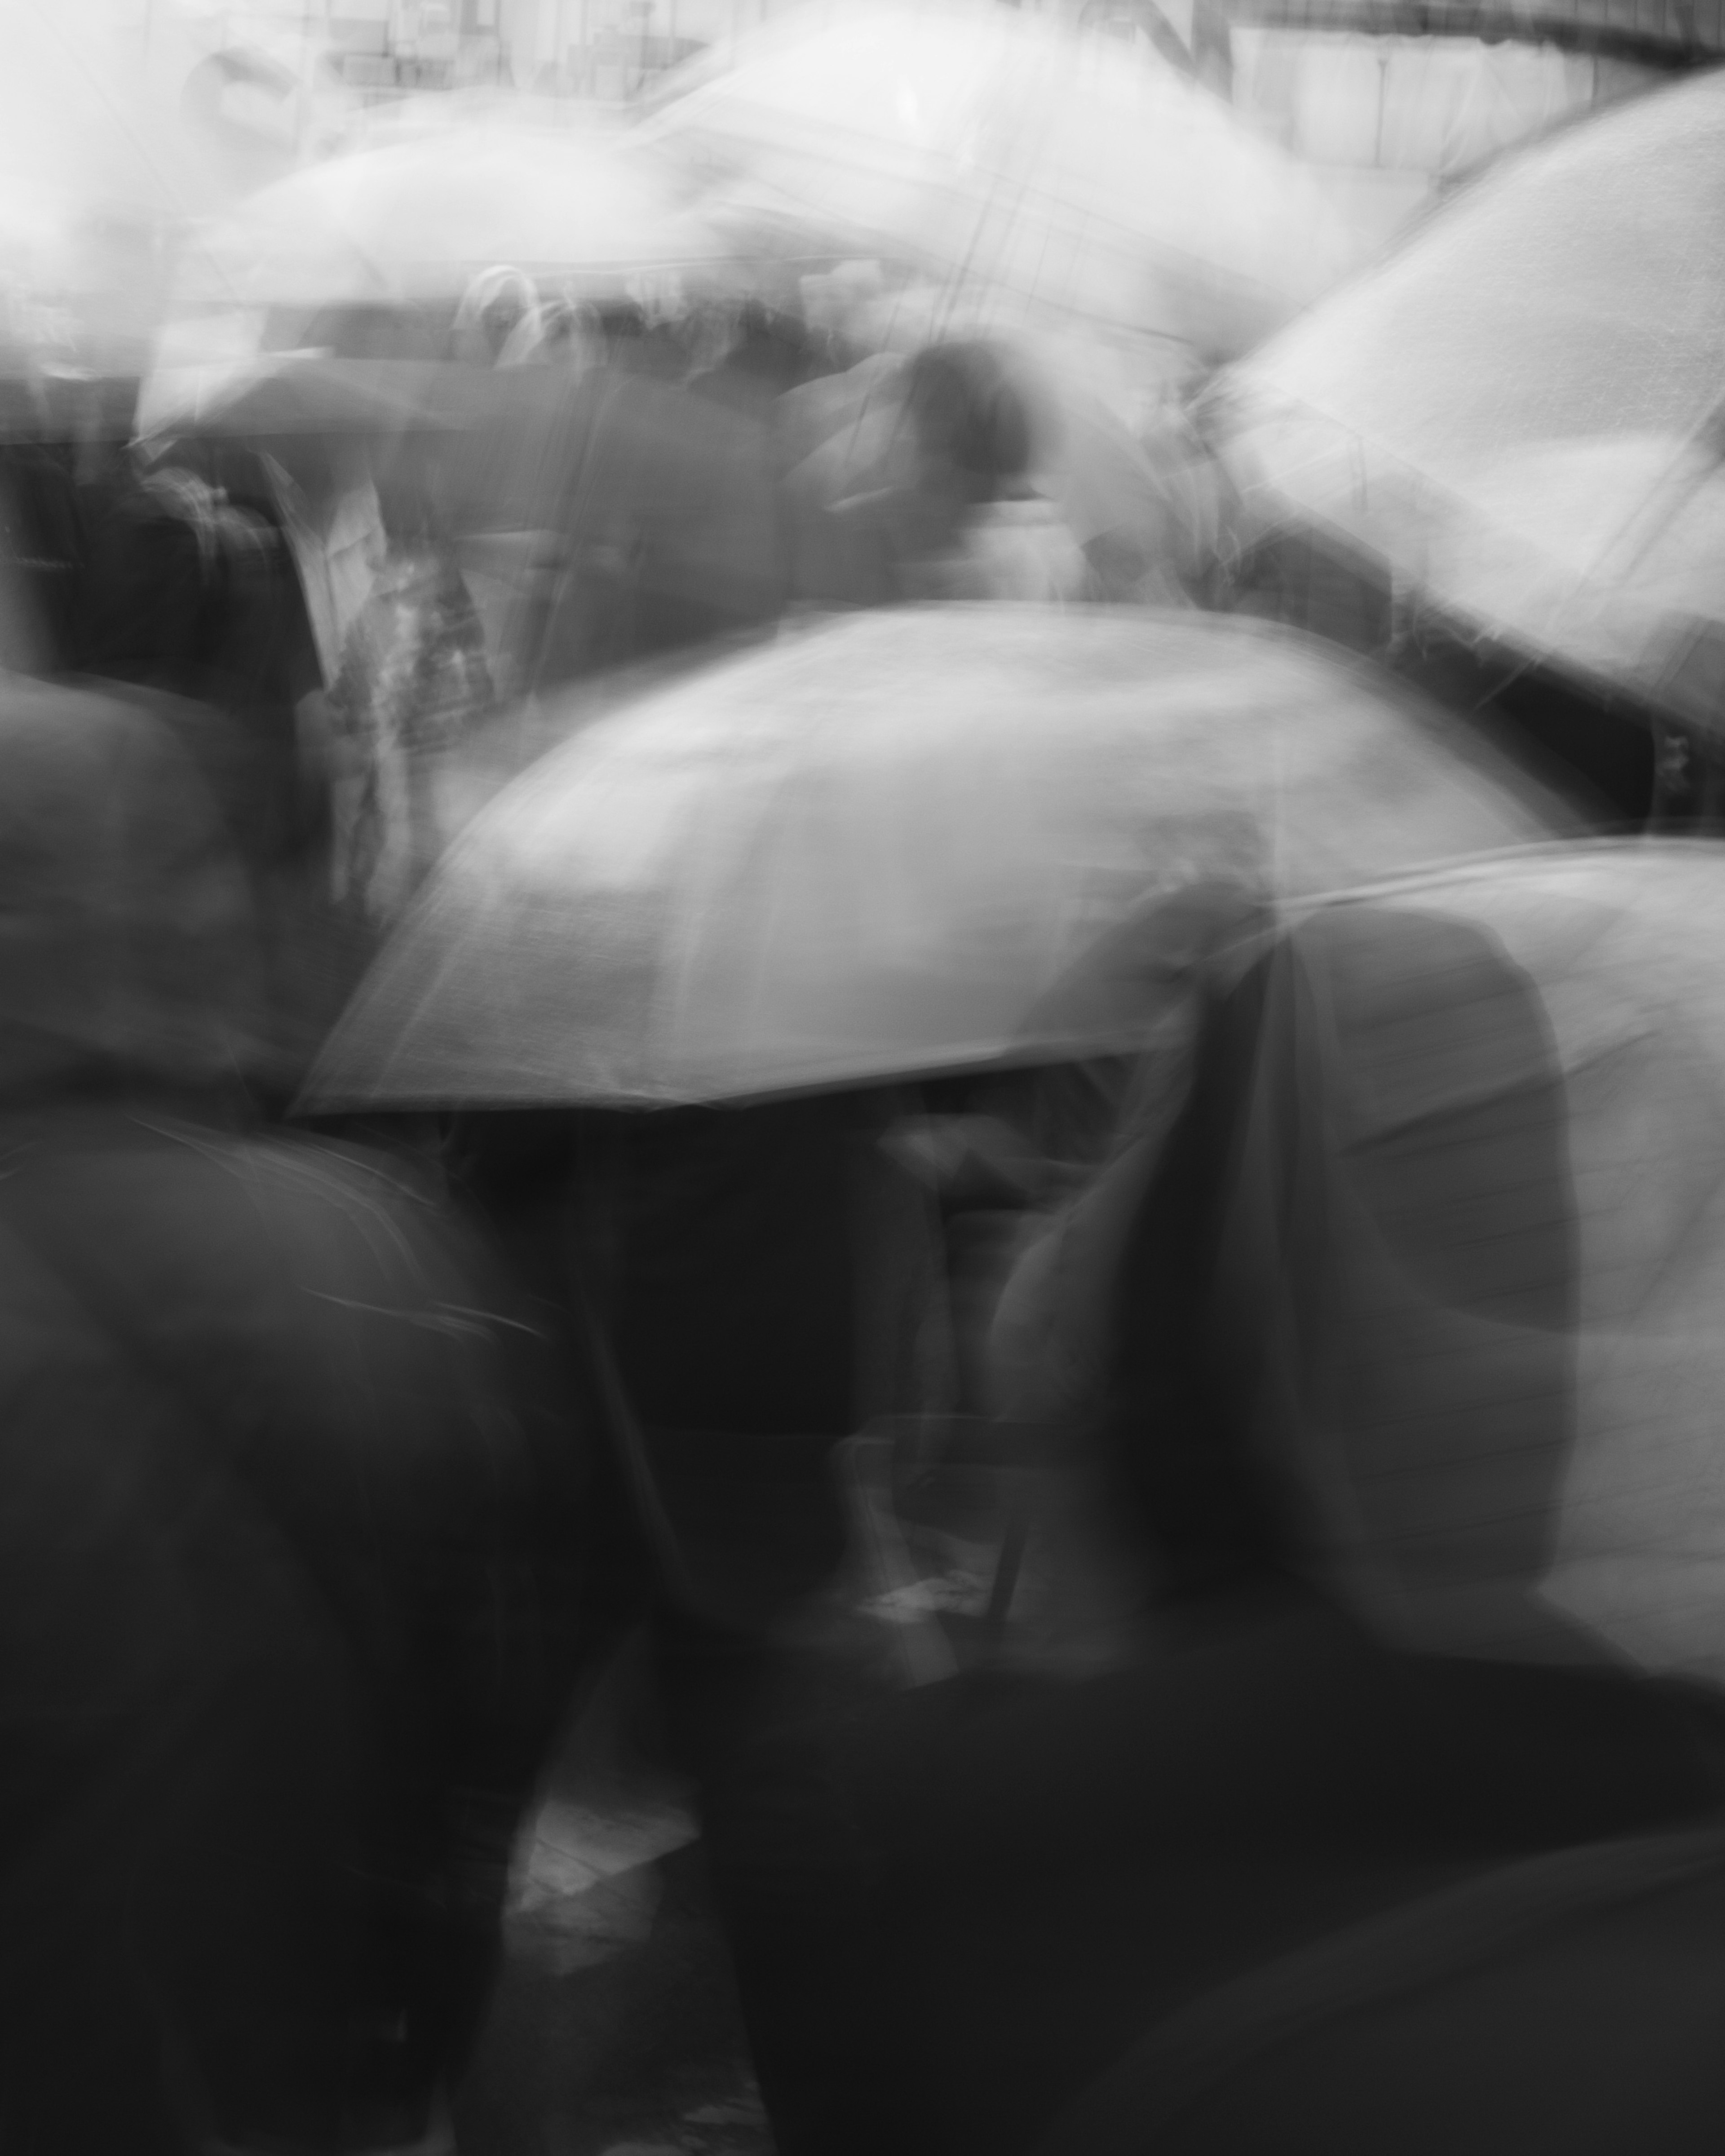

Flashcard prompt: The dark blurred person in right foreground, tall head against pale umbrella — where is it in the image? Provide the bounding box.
[655,908,1725,2156]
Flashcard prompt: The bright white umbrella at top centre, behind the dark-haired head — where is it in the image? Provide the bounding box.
[642,11,1352,356]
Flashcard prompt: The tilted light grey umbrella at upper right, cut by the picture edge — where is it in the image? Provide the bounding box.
[1221,63,1725,718]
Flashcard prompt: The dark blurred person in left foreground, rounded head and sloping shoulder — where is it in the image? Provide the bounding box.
[0,684,580,2156]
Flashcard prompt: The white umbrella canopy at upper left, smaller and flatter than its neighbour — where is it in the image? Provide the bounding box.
[179,121,742,310]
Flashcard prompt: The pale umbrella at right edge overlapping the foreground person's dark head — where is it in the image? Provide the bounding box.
[1259,841,1725,1684]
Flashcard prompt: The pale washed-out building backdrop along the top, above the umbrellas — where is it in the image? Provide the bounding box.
[23,0,1725,224]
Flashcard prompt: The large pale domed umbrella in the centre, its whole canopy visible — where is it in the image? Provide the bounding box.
[308,606,1561,1106]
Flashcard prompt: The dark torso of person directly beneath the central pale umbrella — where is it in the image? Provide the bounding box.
[451,1089,951,1628]
